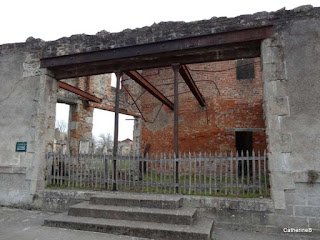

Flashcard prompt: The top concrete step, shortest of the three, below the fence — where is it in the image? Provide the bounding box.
[90,192,183,209]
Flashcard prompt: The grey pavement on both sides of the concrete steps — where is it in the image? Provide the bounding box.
[0,207,316,240]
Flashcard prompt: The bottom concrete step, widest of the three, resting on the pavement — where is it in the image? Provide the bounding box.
[44,213,213,240]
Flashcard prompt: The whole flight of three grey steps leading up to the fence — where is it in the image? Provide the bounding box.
[44,192,213,240]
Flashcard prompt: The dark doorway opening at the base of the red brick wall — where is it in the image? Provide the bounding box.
[236,132,253,176]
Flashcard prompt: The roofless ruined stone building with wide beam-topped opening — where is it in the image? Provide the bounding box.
[0,6,320,234]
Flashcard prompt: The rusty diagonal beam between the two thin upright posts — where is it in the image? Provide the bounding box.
[124,71,174,110]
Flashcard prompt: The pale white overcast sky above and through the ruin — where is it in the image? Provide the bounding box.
[0,0,320,140]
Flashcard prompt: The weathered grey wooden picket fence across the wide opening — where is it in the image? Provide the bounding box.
[47,151,269,197]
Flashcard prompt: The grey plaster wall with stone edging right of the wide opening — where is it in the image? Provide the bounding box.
[262,19,320,229]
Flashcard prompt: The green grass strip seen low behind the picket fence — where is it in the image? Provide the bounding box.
[46,173,269,198]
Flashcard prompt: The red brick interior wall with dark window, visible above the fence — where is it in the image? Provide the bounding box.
[141,58,266,153]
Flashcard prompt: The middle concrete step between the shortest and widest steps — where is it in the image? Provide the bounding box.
[68,202,197,225]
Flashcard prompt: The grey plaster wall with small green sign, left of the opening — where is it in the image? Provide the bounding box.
[0,44,57,205]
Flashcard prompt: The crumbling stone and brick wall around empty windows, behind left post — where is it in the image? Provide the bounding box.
[58,74,136,154]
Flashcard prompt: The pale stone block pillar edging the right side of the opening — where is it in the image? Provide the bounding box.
[261,36,294,209]
